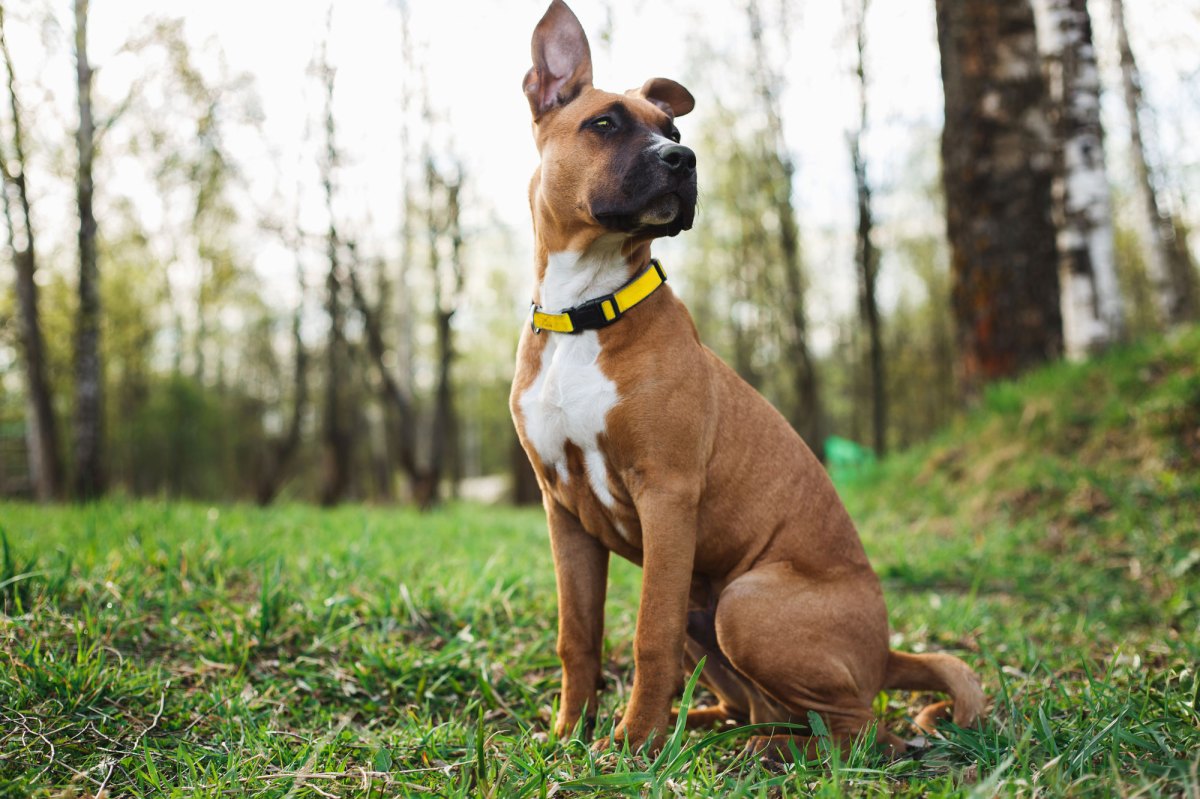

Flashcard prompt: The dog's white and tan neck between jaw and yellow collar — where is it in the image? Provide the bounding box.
[534,233,650,311]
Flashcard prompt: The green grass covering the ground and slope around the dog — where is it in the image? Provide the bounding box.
[0,331,1200,799]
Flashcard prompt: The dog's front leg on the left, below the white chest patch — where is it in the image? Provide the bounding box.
[545,497,608,738]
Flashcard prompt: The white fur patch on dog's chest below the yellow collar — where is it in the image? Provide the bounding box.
[521,330,618,505]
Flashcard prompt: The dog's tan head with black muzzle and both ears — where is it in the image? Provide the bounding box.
[523,0,696,247]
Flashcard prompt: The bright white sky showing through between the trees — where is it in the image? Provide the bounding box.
[8,0,1200,352]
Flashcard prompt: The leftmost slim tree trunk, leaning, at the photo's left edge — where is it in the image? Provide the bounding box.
[0,5,62,501]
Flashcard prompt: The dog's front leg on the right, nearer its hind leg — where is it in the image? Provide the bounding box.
[596,487,698,749]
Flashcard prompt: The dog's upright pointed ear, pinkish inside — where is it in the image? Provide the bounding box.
[524,0,592,121]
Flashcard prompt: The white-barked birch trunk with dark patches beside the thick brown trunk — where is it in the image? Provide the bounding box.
[1036,0,1124,359]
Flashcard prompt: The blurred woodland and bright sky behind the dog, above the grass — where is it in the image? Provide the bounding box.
[0,0,1200,506]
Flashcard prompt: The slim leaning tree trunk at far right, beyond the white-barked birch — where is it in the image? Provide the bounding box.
[1112,0,1200,325]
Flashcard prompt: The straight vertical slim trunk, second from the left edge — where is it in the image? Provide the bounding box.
[74,0,104,500]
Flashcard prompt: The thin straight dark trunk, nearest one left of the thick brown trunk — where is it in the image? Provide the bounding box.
[850,0,888,457]
